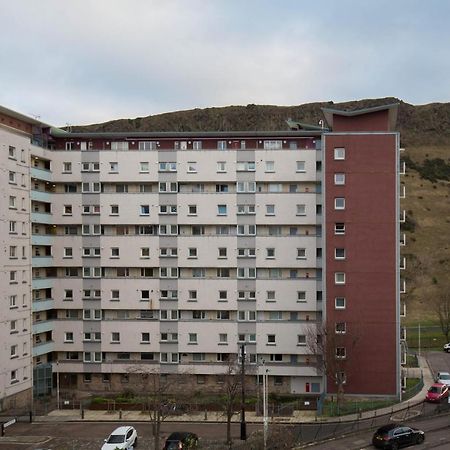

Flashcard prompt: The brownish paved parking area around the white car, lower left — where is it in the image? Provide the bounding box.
[0,422,261,450]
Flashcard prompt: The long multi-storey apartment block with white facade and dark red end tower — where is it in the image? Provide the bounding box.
[0,105,400,408]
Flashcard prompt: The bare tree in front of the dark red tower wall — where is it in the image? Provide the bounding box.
[306,322,358,410]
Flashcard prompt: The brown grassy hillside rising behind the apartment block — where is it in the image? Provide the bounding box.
[73,97,450,325]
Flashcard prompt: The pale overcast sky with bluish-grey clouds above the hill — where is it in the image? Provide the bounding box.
[0,0,450,126]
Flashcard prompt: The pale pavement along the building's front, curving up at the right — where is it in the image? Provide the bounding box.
[30,356,434,424]
